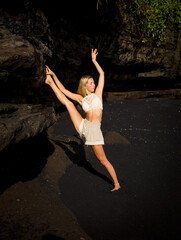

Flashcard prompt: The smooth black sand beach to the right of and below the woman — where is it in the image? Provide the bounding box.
[51,99,181,240]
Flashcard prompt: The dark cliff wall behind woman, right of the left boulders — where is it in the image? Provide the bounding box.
[39,0,181,91]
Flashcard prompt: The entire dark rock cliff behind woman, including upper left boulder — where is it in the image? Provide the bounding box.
[0,0,181,150]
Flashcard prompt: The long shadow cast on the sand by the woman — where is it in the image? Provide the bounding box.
[52,136,114,185]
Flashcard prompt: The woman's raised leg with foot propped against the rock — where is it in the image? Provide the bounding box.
[45,75,83,133]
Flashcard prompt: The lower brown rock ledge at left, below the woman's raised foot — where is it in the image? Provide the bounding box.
[0,104,57,151]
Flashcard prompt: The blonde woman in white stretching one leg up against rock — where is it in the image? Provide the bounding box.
[45,49,120,192]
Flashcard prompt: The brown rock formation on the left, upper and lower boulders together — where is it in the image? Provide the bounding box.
[0,1,56,151]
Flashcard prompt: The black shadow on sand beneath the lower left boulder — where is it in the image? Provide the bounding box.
[0,133,54,194]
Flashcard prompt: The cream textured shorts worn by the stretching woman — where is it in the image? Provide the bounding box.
[79,118,104,145]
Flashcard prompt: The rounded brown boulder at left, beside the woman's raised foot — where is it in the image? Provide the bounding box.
[0,28,44,102]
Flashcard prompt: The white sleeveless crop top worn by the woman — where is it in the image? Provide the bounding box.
[82,93,103,112]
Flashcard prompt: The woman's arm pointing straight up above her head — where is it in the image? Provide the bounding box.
[92,49,104,98]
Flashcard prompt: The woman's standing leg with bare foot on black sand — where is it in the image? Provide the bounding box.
[92,145,120,192]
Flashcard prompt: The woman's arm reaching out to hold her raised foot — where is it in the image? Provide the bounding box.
[46,65,83,104]
